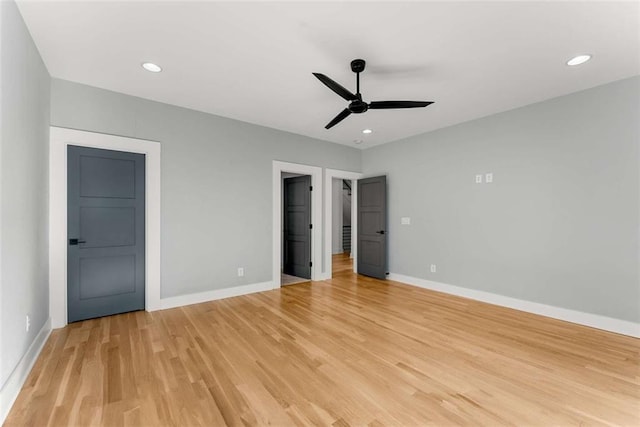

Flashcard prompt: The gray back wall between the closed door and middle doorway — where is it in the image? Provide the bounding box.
[51,79,361,297]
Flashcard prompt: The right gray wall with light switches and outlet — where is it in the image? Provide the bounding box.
[362,77,640,322]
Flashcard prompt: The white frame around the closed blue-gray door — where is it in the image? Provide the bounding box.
[49,126,160,328]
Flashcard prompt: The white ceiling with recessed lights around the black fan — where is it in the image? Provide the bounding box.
[19,1,640,148]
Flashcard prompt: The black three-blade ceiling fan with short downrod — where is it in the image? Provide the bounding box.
[313,59,433,129]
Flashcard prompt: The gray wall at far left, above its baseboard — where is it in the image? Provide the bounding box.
[0,1,50,388]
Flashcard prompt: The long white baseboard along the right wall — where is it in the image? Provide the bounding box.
[388,273,640,338]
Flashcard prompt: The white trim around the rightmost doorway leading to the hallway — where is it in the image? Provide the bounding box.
[322,169,363,280]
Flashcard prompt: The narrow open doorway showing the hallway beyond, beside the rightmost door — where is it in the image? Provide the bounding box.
[331,178,353,276]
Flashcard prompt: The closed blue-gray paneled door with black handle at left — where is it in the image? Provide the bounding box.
[67,146,145,322]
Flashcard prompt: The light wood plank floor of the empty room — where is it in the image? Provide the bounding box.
[6,257,640,426]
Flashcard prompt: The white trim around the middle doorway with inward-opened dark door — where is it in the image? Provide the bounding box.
[271,160,322,288]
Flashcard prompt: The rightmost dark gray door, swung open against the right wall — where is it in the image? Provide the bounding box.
[358,176,387,279]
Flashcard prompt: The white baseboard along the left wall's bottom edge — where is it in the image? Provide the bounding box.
[0,318,51,425]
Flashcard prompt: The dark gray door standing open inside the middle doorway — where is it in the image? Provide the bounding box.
[283,175,312,279]
